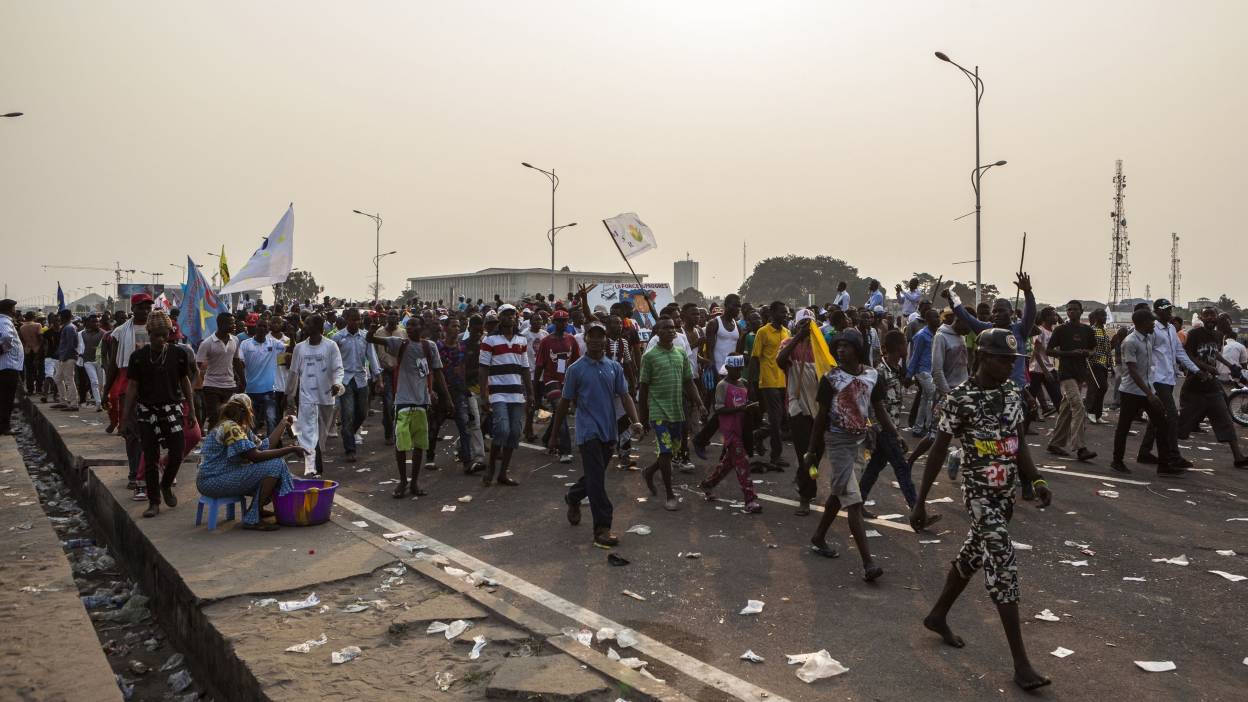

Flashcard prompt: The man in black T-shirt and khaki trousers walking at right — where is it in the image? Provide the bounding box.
[1047,300,1096,461]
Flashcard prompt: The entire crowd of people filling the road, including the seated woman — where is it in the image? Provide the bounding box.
[0,274,1248,688]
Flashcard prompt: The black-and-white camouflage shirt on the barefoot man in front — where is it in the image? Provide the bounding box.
[936,377,1025,497]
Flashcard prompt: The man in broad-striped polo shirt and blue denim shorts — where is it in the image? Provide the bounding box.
[480,305,533,486]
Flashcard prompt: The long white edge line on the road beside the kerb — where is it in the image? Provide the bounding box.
[334,493,789,702]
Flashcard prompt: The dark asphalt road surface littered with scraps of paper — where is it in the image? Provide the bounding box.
[309,397,1248,700]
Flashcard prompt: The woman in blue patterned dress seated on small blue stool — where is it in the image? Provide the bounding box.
[195,393,307,531]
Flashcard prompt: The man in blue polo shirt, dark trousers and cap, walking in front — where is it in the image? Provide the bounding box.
[550,322,645,548]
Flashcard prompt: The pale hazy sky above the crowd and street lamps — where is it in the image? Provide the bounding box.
[0,0,1248,304]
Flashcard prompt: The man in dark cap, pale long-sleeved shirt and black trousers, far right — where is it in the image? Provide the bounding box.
[1136,297,1204,468]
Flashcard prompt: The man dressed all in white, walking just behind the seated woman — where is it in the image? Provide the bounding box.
[286,315,344,476]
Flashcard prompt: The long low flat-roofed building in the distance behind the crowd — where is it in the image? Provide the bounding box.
[407,264,643,302]
